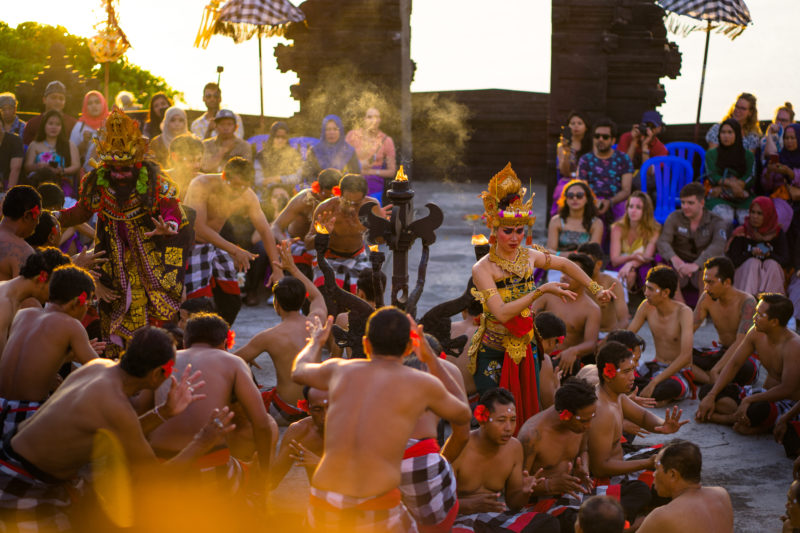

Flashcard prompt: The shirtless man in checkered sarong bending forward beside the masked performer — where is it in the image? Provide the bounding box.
[185,157,283,325]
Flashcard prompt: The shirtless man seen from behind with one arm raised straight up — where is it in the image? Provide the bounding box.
[236,241,327,426]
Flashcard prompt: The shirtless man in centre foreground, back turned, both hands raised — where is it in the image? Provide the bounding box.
[292,307,470,532]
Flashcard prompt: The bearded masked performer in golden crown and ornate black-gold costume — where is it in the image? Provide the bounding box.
[59,108,192,358]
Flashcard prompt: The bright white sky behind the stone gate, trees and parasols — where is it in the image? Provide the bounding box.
[0,0,800,123]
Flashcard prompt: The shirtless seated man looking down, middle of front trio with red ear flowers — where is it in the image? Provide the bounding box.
[519,378,597,533]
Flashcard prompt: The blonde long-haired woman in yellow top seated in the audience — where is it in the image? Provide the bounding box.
[610,191,661,292]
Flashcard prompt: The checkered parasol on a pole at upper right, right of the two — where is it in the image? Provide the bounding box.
[657,0,752,142]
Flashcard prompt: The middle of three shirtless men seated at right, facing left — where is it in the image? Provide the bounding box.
[692,255,758,386]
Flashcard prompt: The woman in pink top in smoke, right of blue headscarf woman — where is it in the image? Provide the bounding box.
[345,107,397,205]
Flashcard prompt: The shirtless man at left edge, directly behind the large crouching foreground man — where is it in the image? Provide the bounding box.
[0,265,105,435]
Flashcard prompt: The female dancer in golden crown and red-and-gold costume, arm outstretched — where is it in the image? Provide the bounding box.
[468,163,613,434]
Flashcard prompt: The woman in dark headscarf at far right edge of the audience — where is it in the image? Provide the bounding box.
[761,124,800,231]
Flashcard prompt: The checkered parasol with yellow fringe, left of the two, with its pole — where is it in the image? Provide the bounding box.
[194,0,306,118]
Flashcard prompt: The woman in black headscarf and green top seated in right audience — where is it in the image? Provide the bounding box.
[706,118,754,224]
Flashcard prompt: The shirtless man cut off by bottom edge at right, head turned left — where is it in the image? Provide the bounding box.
[637,441,733,533]
